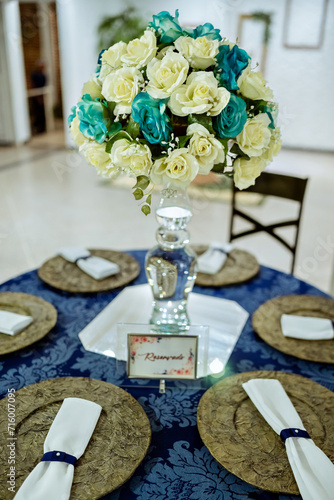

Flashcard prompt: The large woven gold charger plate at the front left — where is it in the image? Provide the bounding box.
[0,377,151,500]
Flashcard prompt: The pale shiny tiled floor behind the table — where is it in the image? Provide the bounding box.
[0,132,334,291]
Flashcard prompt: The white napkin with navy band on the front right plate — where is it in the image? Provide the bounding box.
[242,379,334,500]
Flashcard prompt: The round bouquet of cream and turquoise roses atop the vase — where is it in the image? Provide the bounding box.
[69,11,281,215]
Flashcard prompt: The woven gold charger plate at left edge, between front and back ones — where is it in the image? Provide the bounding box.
[0,292,57,354]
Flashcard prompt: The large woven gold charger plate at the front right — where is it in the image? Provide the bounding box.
[197,371,334,495]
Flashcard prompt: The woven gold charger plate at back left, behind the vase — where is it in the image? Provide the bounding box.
[38,250,140,293]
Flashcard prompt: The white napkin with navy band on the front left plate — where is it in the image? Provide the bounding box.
[14,398,102,500]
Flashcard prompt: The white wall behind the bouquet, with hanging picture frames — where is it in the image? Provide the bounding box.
[57,0,334,151]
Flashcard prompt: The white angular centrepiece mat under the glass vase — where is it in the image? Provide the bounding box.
[79,284,249,375]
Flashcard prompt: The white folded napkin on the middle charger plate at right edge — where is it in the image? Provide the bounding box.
[281,314,334,340]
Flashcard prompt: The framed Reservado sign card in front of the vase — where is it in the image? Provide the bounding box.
[127,333,198,379]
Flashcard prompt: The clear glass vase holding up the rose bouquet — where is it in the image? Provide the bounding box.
[145,187,197,333]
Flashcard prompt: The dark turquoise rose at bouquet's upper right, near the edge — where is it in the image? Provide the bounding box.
[215,45,250,90]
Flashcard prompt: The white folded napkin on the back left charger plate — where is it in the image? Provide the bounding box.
[59,247,120,280]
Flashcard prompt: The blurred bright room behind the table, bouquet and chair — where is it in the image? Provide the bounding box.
[0,0,334,294]
